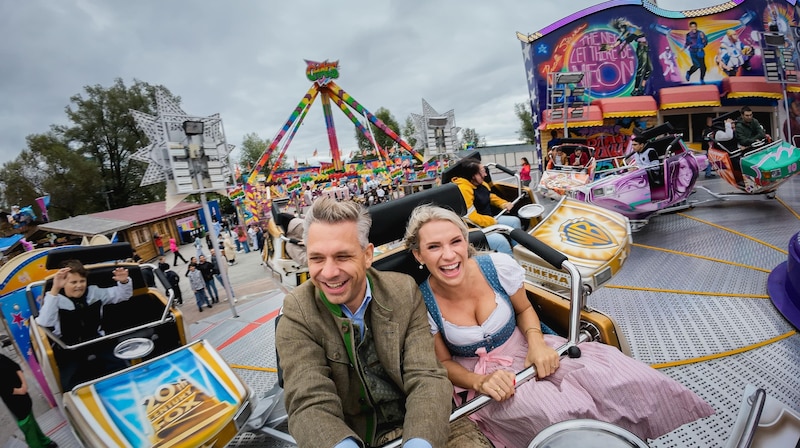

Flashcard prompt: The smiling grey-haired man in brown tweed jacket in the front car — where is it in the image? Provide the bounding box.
[275,198,490,448]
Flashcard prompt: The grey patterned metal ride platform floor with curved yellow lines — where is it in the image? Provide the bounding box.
[225,176,800,448]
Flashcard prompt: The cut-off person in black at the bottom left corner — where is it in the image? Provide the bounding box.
[0,353,58,448]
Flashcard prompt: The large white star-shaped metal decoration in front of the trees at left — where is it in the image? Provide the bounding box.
[130,91,234,208]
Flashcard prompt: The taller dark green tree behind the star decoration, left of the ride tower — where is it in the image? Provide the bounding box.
[54,78,180,209]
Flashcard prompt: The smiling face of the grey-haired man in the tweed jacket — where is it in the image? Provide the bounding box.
[306,222,373,312]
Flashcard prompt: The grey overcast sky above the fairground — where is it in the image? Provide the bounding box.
[0,0,721,163]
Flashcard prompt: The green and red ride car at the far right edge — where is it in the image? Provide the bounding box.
[701,111,800,198]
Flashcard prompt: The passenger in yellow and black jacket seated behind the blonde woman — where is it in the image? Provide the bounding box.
[452,159,522,255]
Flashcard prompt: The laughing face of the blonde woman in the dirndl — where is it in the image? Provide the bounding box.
[414,221,469,283]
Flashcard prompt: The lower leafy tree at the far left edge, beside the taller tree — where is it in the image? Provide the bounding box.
[0,131,105,220]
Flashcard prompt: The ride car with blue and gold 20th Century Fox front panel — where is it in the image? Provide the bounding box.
[7,243,253,447]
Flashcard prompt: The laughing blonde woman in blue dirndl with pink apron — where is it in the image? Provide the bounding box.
[405,205,714,447]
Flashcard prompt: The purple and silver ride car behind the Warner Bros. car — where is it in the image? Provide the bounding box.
[569,123,706,231]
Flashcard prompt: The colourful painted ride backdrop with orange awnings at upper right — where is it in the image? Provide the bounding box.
[517,0,800,164]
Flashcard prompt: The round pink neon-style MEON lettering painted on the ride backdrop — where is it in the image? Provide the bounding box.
[566,29,636,97]
